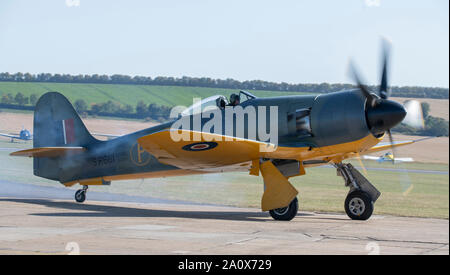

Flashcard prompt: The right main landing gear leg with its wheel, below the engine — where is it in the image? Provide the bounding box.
[335,163,381,220]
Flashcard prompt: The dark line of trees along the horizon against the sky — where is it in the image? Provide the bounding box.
[0,72,449,99]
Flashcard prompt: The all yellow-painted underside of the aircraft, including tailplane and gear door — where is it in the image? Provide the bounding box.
[44,130,414,211]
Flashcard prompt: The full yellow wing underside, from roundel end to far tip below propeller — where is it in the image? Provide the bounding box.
[138,130,413,169]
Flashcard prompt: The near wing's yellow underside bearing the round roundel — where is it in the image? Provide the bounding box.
[138,130,308,169]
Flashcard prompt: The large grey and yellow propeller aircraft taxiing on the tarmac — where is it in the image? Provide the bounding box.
[11,43,426,220]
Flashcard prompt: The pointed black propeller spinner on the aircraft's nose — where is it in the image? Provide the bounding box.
[367,99,406,133]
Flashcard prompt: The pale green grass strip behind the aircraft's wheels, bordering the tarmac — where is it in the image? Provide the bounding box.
[0,141,449,219]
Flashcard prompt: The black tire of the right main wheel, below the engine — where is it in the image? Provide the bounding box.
[345,190,373,221]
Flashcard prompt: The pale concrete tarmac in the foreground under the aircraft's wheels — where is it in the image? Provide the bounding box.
[0,182,449,255]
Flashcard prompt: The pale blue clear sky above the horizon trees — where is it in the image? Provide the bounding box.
[0,0,449,88]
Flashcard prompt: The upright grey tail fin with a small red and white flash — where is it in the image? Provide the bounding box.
[33,92,97,148]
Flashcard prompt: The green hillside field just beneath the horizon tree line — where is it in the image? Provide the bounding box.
[0,82,307,107]
